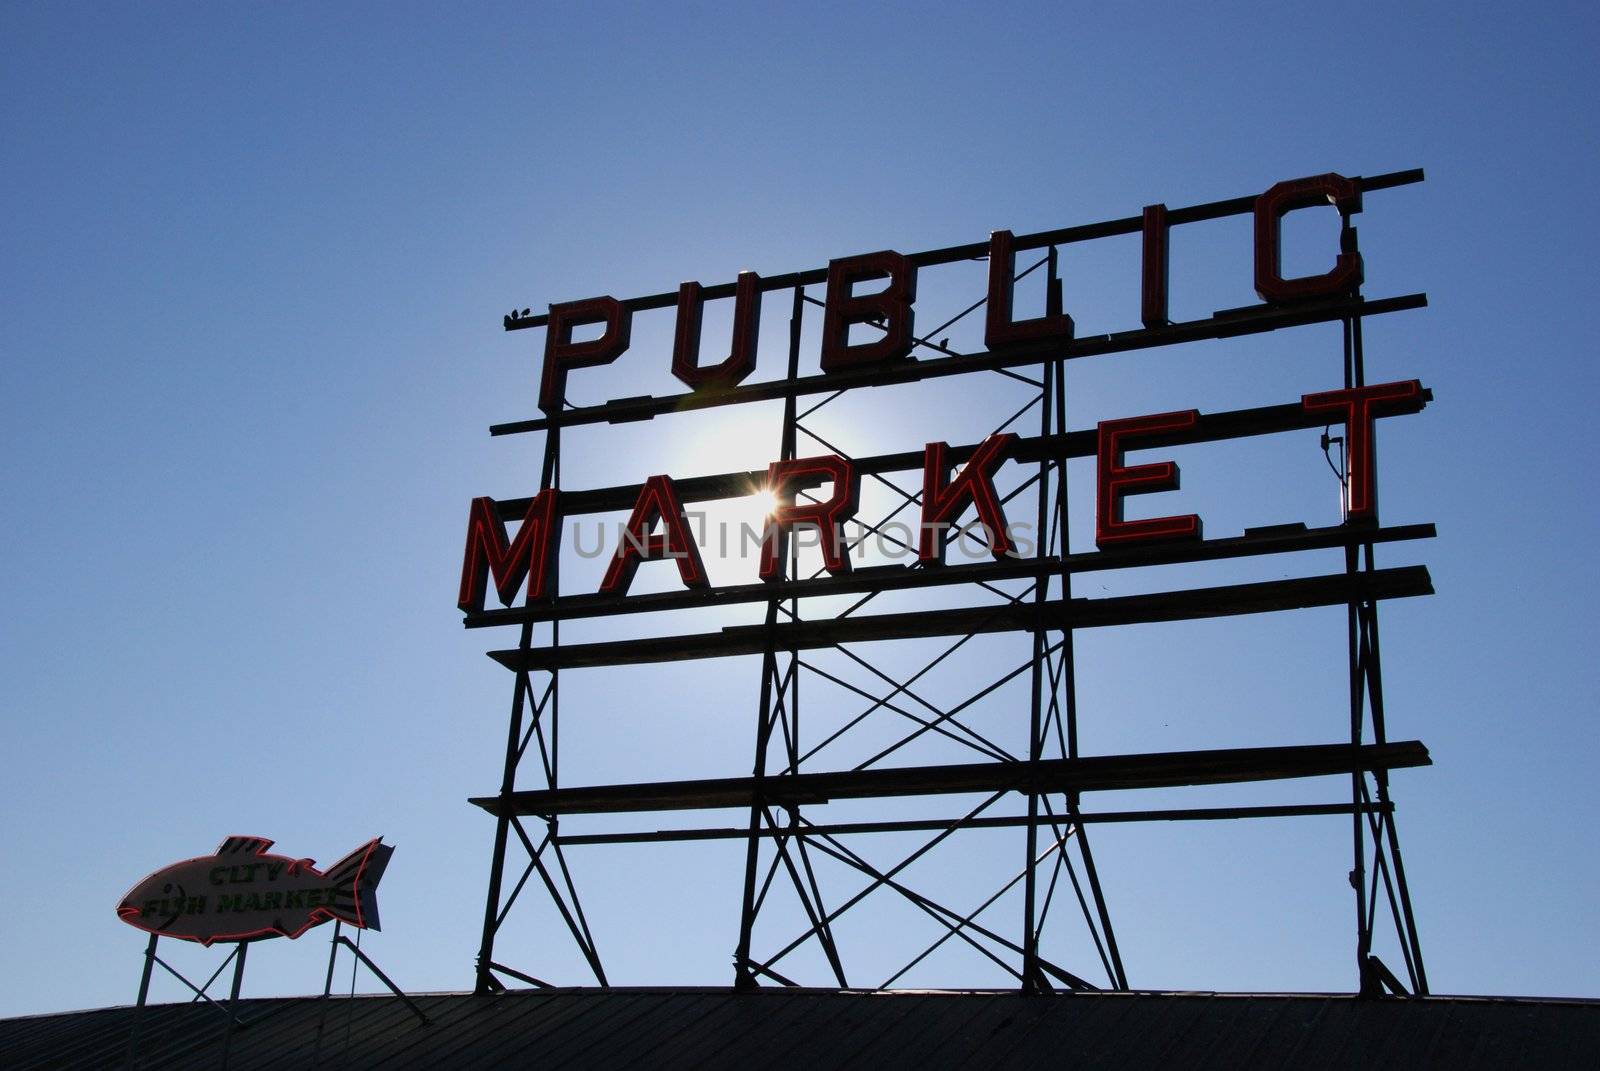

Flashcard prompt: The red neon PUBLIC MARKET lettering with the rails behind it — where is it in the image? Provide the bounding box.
[458,173,1429,614]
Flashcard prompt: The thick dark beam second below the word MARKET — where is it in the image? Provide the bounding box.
[490,565,1434,671]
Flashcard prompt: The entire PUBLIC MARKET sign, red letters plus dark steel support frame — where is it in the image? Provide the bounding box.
[461,170,1435,994]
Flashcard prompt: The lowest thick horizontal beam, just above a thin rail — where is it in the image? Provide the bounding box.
[470,740,1432,813]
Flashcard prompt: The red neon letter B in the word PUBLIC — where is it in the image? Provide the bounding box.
[822,250,917,371]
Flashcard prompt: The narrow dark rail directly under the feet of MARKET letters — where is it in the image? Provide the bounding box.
[464,523,1437,629]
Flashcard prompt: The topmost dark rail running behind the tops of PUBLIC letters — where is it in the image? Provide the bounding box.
[504,168,1424,331]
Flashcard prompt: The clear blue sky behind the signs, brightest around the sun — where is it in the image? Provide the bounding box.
[0,3,1600,1015]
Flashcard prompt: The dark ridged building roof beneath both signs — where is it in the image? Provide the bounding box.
[0,988,1600,1071]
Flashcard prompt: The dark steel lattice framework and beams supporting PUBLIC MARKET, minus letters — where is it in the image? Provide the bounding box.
[467,164,1434,994]
